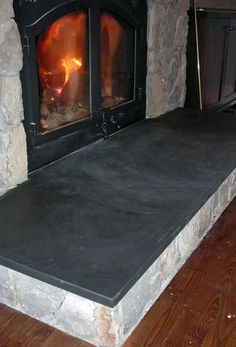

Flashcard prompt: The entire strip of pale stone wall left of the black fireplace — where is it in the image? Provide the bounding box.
[0,0,27,195]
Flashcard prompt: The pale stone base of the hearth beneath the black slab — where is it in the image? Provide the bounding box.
[0,169,236,347]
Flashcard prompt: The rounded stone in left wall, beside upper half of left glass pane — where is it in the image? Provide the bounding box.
[0,19,22,75]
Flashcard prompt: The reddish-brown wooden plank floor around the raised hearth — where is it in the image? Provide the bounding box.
[0,200,236,347]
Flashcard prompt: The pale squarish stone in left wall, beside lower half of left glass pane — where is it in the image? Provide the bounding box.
[0,74,23,125]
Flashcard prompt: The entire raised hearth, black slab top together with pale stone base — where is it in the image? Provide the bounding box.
[0,109,236,346]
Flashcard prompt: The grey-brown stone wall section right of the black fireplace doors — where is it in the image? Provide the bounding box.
[147,0,189,117]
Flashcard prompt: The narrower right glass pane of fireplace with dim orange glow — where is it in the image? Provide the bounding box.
[101,12,134,108]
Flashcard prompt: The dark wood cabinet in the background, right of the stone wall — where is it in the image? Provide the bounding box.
[186,10,236,110]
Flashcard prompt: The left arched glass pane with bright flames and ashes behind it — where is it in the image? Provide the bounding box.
[37,11,90,132]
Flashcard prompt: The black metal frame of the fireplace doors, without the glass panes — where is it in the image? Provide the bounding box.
[14,0,147,171]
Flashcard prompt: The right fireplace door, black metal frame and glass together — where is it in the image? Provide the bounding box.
[97,6,146,137]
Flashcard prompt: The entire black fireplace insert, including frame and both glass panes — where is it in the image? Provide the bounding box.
[14,0,147,171]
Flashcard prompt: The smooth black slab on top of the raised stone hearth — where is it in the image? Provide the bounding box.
[0,109,236,306]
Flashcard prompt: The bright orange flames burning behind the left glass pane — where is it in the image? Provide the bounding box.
[38,12,88,104]
